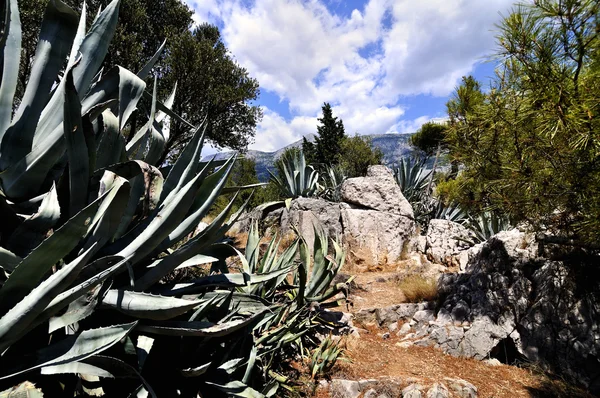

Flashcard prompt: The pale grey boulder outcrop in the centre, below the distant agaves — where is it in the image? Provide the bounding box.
[236,166,415,264]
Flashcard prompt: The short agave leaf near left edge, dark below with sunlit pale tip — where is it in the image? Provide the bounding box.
[6,184,60,256]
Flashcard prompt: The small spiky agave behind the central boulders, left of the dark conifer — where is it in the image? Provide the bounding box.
[269,151,319,198]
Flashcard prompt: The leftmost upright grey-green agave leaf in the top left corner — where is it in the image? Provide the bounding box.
[0,0,21,141]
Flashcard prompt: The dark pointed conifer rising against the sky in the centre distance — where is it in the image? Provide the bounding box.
[302,103,346,165]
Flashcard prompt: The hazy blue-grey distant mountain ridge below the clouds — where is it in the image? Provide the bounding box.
[203,134,422,181]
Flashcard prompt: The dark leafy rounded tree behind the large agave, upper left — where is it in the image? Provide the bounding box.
[17,0,262,164]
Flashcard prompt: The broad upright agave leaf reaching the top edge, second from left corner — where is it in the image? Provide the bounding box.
[1,1,79,169]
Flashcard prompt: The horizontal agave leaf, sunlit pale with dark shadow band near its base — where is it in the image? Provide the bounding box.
[102,289,200,321]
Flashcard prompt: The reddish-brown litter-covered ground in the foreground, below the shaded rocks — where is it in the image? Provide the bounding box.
[317,333,591,398]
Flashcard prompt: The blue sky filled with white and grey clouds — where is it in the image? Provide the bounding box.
[185,0,513,151]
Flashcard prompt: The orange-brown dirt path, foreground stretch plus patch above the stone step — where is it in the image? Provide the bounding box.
[317,272,591,398]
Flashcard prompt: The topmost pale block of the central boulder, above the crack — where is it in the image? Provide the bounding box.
[341,165,414,219]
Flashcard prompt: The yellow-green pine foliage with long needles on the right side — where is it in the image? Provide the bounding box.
[448,0,600,242]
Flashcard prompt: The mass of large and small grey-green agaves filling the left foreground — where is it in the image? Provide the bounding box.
[0,0,344,397]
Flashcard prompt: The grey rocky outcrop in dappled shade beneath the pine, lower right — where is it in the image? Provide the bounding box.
[404,229,600,393]
